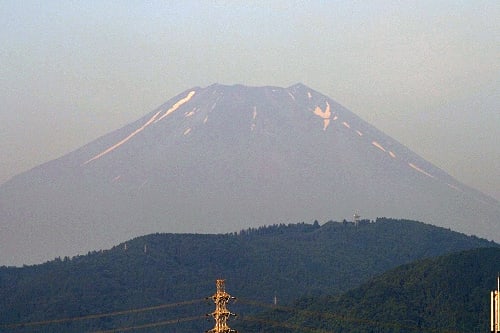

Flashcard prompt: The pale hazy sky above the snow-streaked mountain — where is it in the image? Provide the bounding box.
[0,0,500,199]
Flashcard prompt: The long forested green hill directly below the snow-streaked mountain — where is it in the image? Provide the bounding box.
[0,218,496,332]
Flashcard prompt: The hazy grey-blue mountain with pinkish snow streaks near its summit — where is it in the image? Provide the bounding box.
[0,84,500,265]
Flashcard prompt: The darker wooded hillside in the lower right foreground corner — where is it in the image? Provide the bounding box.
[243,247,500,333]
